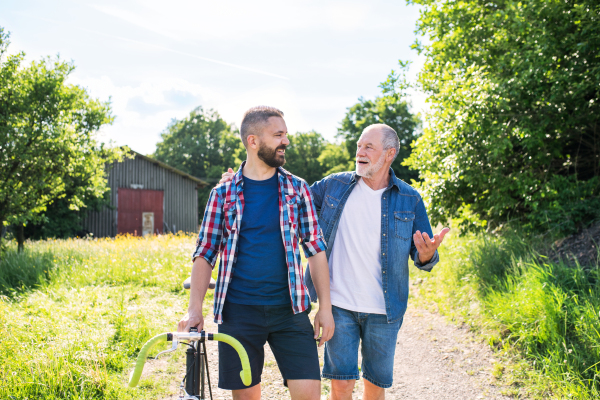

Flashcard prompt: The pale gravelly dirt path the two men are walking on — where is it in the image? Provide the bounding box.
[156,299,509,400]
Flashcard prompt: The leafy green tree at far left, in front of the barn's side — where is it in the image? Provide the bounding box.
[0,28,119,250]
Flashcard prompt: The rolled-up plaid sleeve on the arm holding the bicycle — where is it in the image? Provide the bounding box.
[192,189,224,268]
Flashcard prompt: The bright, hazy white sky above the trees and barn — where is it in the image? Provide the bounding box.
[0,0,425,154]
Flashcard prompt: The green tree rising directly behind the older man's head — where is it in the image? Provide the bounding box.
[338,89,420,182]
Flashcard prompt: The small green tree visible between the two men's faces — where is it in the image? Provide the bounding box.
[284,131,327,185]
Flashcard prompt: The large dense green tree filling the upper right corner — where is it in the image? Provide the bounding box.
[408,0,600,231]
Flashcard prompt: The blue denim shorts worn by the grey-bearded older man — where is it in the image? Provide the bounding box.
[322,306,402,388]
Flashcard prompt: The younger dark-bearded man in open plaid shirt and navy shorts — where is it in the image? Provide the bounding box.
[178,106,334,400]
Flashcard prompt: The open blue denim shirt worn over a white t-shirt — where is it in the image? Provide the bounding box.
[305,168,439,323]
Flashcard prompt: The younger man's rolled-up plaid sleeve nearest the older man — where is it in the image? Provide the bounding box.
[298,181,327,258]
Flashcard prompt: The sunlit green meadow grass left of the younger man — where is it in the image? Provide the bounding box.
[0,235,212,399]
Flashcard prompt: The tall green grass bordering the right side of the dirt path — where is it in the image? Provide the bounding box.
[414,233,600,399]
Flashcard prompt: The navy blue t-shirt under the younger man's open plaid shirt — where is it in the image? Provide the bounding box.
[226,173,291,305]
